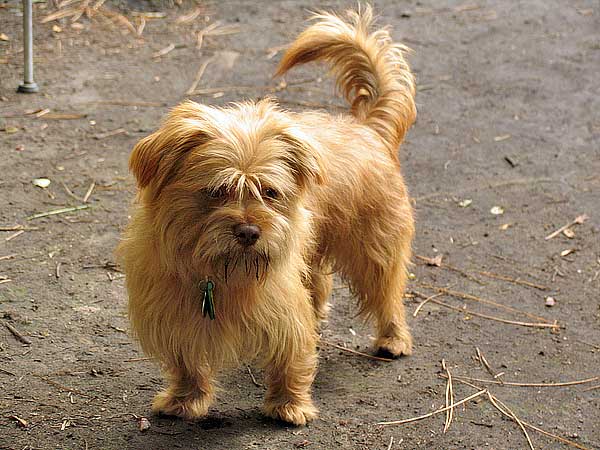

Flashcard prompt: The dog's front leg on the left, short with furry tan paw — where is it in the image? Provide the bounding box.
[152,367,214,420]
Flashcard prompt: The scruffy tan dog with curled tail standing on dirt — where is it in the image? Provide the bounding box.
[119,8,415,425]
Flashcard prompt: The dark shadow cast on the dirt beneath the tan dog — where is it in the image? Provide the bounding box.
[127,352,393,450]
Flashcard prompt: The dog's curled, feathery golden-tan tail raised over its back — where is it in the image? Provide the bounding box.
[277,6,416,154]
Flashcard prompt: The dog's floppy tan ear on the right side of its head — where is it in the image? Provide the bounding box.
[280,125,326,189]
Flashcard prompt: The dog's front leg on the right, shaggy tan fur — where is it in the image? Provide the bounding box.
[264,334,318,425]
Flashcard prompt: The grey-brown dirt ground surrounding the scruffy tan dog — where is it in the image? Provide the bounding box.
[0,0,600,449]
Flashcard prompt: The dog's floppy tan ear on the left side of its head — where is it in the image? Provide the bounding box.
[129,101,210,188]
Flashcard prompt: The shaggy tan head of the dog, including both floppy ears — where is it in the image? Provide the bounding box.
[130,100,323,280]
